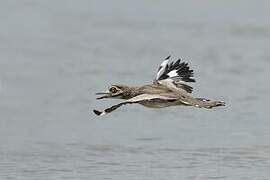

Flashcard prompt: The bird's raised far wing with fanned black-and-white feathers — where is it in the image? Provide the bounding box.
[154,56,195,93]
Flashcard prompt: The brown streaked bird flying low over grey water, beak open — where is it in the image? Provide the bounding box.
[93,56,225,116]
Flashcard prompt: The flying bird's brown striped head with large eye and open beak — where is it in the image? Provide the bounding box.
[96,85,131,99]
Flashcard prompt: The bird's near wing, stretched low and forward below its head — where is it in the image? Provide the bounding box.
[93,94,176,116]
